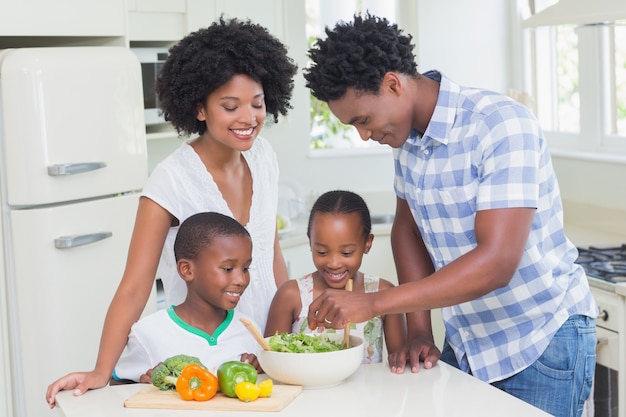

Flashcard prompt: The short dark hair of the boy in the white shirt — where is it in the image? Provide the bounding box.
[174,212,250,261]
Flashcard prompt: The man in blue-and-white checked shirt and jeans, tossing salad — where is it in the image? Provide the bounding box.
[305,15,597,416]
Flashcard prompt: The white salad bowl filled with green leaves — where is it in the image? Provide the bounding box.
[256,333,363,389]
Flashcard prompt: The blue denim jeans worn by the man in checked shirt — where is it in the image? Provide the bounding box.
[441,315,597,417]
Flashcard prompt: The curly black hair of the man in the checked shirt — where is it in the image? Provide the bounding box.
[304,13,419,102]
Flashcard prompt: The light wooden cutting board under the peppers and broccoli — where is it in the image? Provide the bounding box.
[124,384,302,411]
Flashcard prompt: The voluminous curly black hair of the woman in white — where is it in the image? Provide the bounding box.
[155,17,298,135]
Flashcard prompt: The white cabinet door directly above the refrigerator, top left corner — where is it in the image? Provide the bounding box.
[0,0,126,36]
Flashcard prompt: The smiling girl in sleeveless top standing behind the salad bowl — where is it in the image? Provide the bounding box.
[265,191,405,363]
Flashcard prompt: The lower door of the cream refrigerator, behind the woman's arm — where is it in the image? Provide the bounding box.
[9,194,156,416]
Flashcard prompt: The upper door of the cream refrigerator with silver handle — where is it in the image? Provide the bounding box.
[0,46,148,207]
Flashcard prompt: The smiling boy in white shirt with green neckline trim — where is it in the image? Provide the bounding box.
[113,212,259,382]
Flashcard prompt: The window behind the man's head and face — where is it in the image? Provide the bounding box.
[306,0,395,153]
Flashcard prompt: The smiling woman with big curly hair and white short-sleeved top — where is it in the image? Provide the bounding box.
[46,19,297,407]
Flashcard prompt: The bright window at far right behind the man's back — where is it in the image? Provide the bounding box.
[522,0,626,158]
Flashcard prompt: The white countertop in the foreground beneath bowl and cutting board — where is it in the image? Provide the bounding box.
[57,362,548,417]
